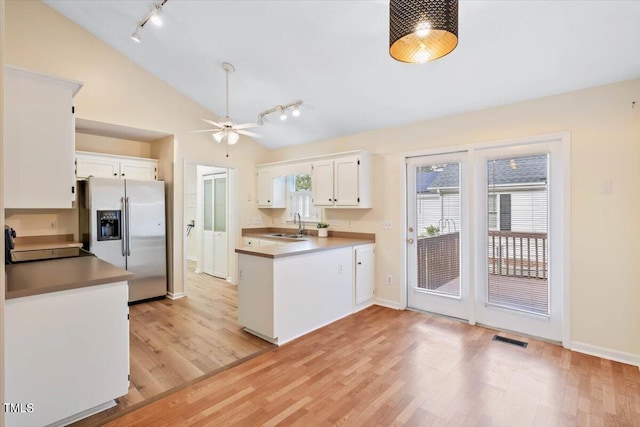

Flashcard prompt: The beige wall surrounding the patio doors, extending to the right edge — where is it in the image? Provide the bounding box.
[269,79,640,360]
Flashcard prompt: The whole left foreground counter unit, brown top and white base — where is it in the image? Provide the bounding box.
[4,254,133,426]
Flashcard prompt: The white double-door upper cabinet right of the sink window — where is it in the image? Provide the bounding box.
[311,151,371,208]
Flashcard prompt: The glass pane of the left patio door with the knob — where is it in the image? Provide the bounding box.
[415,163,461,297]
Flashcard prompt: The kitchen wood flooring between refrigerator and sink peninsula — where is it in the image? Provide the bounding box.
[75,262,274,427]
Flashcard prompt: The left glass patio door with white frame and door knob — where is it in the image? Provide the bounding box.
[407,152,471,319]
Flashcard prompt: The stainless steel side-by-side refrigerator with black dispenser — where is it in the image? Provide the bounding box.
[80,177,167,302]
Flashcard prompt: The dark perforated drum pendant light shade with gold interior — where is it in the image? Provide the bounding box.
[389,0,458,64]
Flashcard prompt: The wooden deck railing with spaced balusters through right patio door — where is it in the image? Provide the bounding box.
[487,230,548,279]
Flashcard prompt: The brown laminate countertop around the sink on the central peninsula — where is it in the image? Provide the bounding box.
[236,231,375,258]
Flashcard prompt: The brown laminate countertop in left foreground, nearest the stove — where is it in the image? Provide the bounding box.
[5,256,133,299]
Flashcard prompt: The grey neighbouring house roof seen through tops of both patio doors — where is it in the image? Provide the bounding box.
[417,155,547,193]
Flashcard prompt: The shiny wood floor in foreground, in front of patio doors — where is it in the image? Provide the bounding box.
[106,306,640,427]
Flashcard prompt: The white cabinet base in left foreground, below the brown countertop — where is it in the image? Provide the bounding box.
[4,282,129,427]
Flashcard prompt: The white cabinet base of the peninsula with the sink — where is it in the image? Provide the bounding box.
[238,247,353,345]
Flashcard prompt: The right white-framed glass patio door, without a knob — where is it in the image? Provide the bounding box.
[474,142,564,341]
